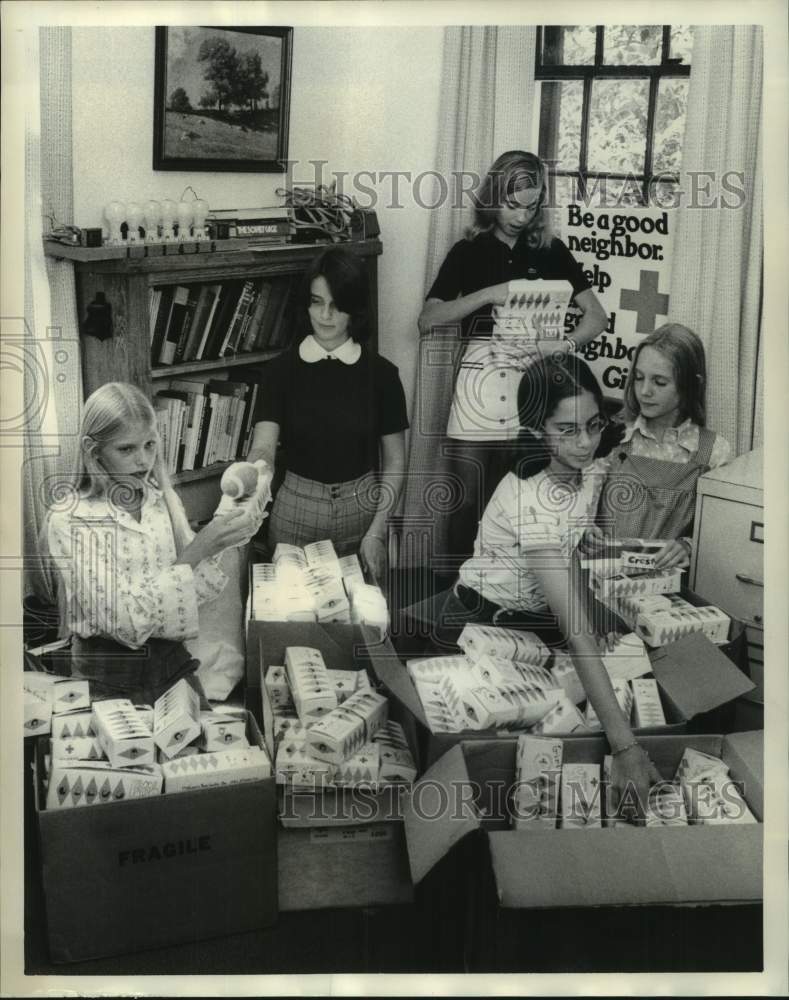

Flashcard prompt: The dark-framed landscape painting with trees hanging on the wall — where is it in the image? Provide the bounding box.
[153,25,293,173]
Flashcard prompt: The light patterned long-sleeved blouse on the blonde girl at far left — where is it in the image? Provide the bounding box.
[47,486,227,649]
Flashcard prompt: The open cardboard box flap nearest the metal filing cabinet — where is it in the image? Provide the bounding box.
[649,632,754,719]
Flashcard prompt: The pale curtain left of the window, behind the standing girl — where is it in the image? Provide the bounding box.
[399,26,536,570]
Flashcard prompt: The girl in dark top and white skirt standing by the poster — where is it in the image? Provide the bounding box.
[419,150,606,557]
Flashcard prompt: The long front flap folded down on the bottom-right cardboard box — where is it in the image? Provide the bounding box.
[488,825,763,908]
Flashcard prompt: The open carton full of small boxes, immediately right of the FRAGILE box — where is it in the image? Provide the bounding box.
[255,622,417,910]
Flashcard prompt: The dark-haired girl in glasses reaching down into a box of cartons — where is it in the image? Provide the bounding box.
[412,355,659,804]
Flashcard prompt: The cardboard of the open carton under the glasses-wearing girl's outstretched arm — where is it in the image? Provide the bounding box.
[375,634,753,769]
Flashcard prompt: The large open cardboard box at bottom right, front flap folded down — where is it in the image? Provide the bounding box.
[404,732,764,971]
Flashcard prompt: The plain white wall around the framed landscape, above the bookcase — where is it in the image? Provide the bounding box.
[68,26,443,401]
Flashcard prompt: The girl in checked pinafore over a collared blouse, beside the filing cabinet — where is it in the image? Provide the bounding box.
[596,323,731,569]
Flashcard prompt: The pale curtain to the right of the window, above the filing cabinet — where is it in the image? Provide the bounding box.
[671,25,763,454]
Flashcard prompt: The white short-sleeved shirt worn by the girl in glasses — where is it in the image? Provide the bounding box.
[460,459,608,611]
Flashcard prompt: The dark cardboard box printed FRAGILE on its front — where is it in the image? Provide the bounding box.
[36,716,277,962]
